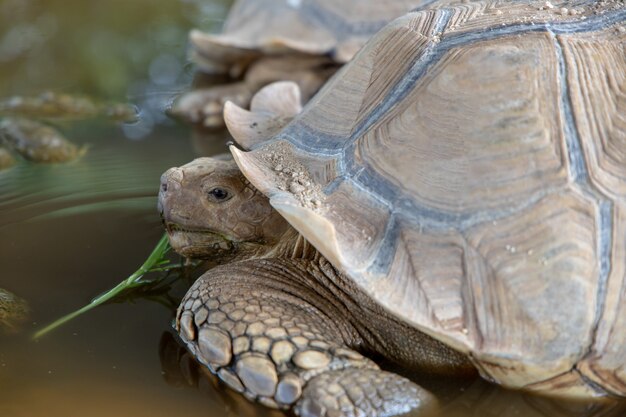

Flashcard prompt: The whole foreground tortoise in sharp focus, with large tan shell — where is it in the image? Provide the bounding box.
[160,1,626,416]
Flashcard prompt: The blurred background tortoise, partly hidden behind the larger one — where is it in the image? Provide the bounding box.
[169,0,476,128]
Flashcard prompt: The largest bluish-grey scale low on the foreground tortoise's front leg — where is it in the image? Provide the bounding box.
[236,355,278,397]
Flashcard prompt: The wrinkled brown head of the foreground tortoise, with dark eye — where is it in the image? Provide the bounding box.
[158,158,289,259]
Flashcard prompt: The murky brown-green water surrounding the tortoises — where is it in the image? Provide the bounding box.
[0,0,626,417]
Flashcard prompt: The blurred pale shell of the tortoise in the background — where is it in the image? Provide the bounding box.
[190,0,460,72]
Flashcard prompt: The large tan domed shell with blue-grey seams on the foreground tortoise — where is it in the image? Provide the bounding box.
[227,2,626,397]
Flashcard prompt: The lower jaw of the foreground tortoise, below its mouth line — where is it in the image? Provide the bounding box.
[165,222,234,259]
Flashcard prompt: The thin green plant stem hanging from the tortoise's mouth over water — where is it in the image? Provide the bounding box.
[33,235,169,339]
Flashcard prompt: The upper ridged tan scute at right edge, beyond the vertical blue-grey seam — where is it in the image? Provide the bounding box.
[559,27,626,199]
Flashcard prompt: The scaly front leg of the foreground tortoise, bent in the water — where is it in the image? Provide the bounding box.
[176,259,436,416]
